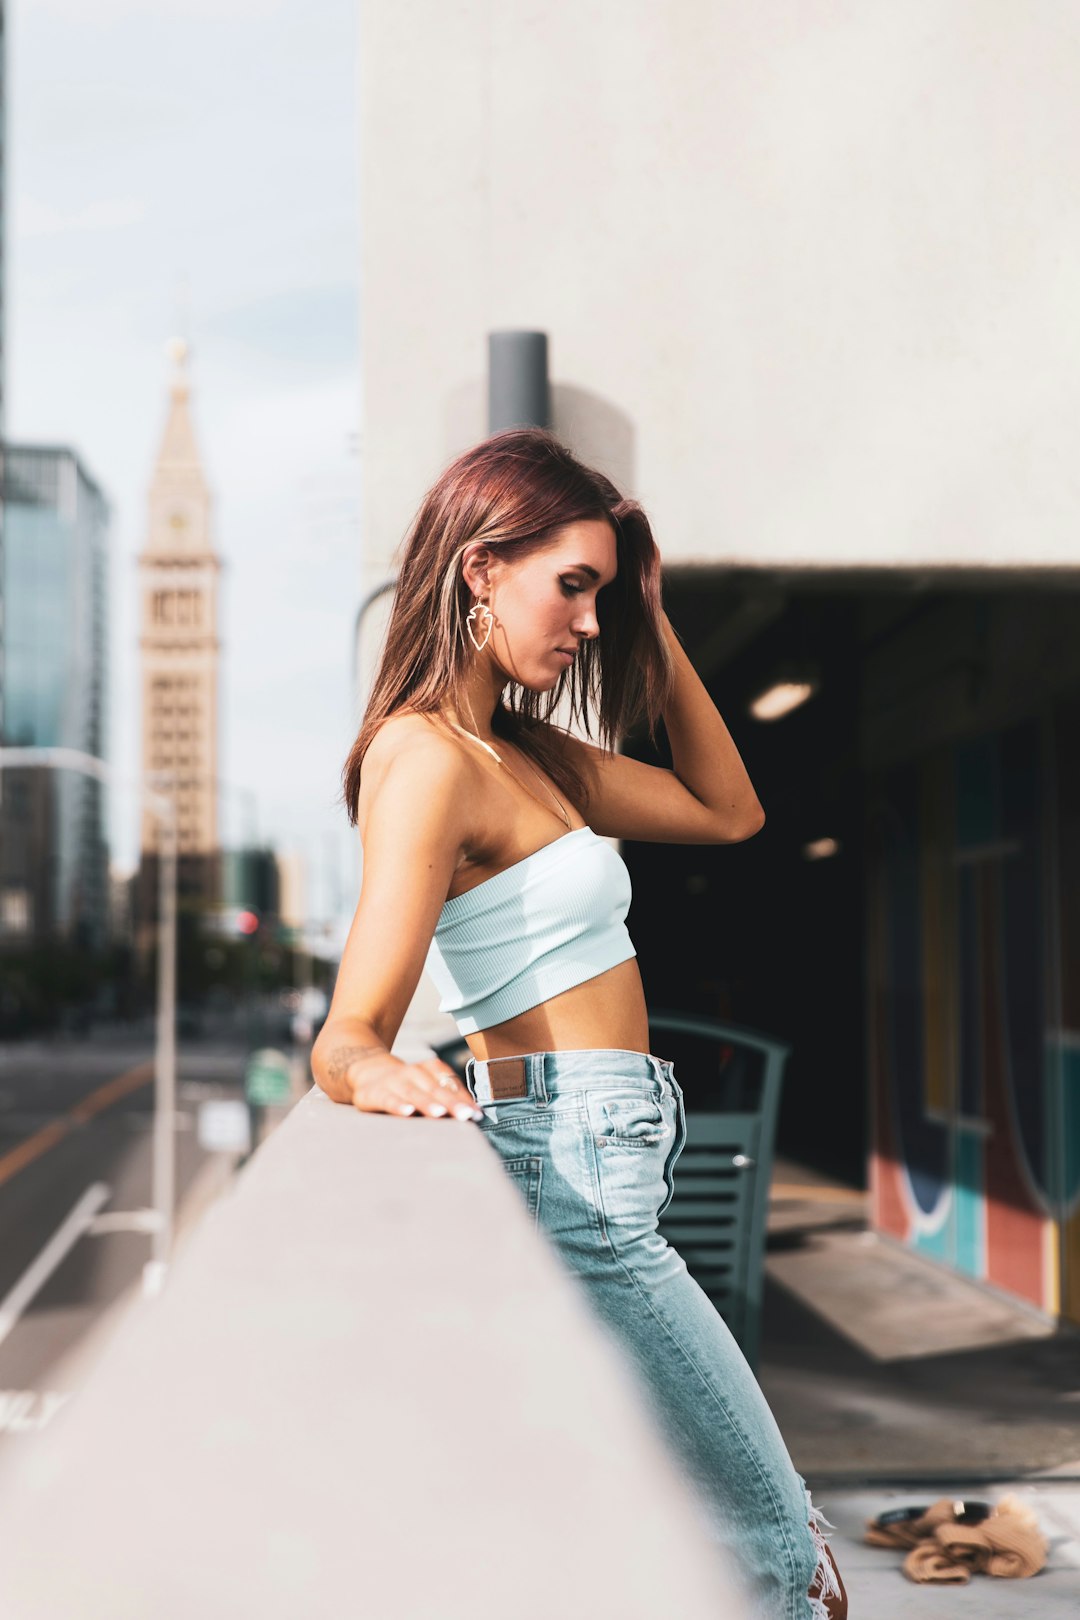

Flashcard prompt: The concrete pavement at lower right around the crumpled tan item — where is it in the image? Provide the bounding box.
[758,1163,1080,1620]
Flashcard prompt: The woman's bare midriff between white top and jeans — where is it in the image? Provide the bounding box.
[465,956,649,1058]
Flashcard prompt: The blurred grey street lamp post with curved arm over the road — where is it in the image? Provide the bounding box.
[0,747,176,1294]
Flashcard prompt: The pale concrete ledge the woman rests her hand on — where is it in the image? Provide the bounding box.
[0,1090,743,1620]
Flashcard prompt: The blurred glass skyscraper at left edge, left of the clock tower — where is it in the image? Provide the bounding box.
[0,446,108,948]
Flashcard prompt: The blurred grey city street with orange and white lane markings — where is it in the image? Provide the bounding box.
[0,1025,248,1445]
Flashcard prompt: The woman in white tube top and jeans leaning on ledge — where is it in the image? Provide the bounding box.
[313,428,847,1620]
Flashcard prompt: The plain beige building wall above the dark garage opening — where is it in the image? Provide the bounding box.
[359,0,1080,582]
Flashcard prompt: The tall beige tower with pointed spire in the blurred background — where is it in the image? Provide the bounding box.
[138,343,222,855]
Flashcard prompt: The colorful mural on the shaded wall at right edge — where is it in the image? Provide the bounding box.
[868,700,1080,1320]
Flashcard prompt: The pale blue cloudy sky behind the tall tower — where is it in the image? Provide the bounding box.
[5,0,359,930]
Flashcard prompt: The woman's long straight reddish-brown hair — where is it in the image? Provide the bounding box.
[342,428,674,826]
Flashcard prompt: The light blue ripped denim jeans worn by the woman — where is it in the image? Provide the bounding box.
[465,1048,824,1620]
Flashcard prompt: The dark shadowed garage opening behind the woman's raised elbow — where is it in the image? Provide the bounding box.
[623,567,1080,1186]
